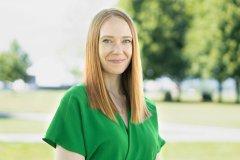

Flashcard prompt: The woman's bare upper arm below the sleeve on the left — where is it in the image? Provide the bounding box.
[56,145,85,160]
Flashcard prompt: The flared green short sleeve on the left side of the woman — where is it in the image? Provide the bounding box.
[42,92,86,156]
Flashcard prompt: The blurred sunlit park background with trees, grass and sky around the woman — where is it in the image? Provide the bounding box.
[0,0,240,160]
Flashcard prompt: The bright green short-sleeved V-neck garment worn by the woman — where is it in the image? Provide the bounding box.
[42,83,165,160]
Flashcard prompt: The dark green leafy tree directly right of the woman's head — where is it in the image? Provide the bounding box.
[120,0,190,100]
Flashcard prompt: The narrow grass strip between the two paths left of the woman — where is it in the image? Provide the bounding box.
[0,119,47,133]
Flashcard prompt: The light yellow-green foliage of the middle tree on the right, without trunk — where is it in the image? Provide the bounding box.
[184,0,220,78]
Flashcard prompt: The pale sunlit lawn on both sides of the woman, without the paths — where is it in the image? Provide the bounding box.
[0,90,240,160]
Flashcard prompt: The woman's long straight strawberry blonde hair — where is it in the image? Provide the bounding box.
[84,8,150,123]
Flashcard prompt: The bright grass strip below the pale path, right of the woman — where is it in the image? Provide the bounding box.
[161,142,240,160]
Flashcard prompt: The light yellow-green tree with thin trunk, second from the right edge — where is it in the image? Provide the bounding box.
[184,0,229,102]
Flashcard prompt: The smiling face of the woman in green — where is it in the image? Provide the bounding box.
[99,17,132,74]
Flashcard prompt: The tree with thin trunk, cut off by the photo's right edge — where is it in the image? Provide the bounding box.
[219,0,240,103]
